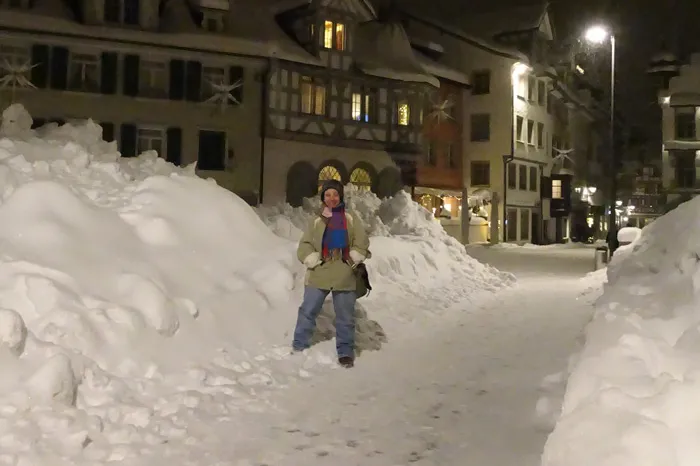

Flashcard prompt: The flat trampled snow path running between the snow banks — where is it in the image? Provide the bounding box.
[221,248,593,466]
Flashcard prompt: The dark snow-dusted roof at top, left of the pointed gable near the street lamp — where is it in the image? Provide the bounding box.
[459,4,547,38]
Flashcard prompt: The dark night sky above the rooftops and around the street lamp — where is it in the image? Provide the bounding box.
[396,0,700,156]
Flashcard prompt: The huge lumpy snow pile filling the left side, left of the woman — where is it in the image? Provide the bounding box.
[0,105,507,466]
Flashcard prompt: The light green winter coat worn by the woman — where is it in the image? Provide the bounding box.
[297,212,371,291]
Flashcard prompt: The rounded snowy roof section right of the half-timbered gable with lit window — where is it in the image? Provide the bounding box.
[353,21,440,87]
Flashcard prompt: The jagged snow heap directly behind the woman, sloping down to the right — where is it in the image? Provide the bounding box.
[258,184,515,325]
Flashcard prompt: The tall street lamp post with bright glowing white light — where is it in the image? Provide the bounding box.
[584,25,618,255]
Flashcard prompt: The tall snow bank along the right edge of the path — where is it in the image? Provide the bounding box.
[542,198,700,466]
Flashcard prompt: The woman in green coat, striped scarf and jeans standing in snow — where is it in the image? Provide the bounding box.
[292,180,370,367]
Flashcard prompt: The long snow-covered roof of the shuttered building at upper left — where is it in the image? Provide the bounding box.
[0,7,322,66]
